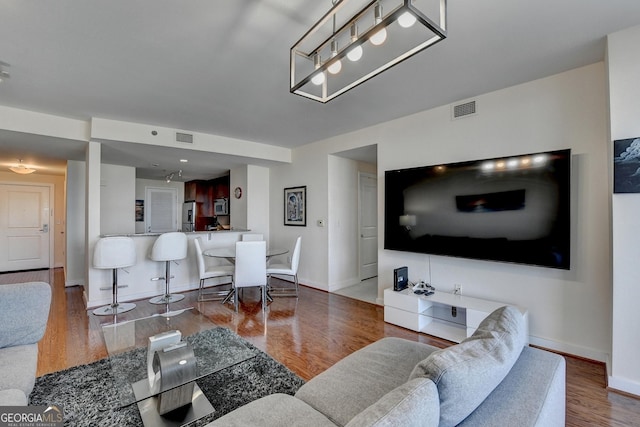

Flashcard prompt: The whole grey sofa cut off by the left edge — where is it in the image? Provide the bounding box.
[0,282,51,406]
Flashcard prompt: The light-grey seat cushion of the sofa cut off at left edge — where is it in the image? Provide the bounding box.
[0,344,38,396]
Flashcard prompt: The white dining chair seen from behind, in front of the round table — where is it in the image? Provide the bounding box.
[233,241,267,313]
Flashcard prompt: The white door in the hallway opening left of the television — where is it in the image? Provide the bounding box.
[359,173,378,280]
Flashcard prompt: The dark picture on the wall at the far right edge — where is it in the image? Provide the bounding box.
[613,138,640,193]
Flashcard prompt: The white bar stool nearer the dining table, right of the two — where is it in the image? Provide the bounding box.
[149,232,187,304]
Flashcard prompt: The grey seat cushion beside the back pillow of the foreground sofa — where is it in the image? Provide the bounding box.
[296,338,437,426]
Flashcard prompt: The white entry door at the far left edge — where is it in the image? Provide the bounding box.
[0,184,52,271]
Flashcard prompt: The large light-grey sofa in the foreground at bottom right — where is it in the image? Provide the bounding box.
[207,306,565,427]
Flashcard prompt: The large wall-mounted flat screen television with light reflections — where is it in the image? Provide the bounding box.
[384,150,571,270]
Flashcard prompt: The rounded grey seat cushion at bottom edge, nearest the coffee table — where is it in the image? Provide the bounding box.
[206,393,335,427]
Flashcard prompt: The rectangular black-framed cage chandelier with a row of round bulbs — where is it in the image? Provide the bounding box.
[289,0,447,103]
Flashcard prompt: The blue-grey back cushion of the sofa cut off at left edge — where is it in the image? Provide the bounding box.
[0,282,51,348]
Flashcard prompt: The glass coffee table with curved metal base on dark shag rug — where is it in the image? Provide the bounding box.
[102,308,257,426]
